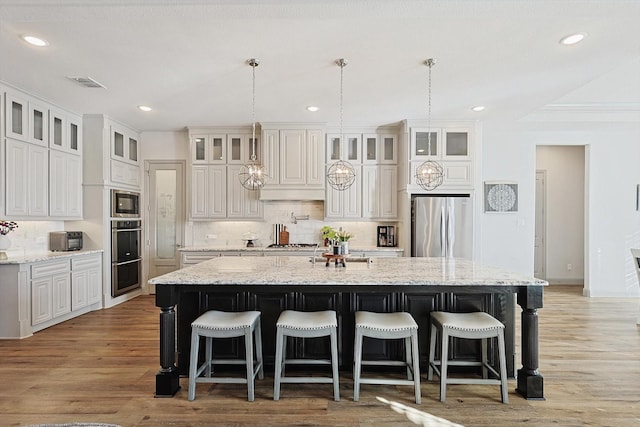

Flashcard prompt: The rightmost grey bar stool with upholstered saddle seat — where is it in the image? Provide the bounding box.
[427,311,509,403]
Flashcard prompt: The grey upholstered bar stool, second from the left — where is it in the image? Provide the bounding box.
[273,310,340,402]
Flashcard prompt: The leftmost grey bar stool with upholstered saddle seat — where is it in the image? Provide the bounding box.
[188,310,264,402]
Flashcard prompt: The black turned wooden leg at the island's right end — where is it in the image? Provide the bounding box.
[516,286,544,400]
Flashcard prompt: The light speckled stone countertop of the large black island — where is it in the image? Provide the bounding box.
[149,256,548,286]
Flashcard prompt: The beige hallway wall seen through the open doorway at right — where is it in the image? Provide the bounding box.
[536,145,585,284]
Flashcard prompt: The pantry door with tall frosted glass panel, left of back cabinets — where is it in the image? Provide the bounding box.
[147,161,185,284]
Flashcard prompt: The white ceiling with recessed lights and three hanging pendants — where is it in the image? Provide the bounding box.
[0,0,640,131]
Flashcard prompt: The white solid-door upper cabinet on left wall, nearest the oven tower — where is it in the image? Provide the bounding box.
[49,150,82,218]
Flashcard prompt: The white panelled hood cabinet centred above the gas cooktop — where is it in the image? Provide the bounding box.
[260,123,325,200]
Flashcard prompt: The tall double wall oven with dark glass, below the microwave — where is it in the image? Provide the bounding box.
[111,220,142,297]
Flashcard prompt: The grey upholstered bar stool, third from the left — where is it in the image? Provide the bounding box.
[353,311,421,404]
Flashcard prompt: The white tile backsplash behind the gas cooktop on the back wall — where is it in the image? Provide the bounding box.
[185,201,396,247]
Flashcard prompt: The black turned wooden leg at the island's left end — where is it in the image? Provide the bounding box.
[155,285,180,397]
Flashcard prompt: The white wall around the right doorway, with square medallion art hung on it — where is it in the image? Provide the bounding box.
[481,114,640,296]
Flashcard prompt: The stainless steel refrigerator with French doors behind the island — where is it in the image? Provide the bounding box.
[411,194,473,259]
